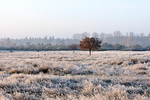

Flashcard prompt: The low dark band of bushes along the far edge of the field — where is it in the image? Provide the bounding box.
[0,43,150,51]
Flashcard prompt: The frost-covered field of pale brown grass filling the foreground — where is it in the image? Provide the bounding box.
[0,51,150,100]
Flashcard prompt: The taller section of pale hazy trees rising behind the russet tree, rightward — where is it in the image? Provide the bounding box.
[73,31,150,47]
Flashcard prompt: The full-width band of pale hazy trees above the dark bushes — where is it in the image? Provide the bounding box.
[0,31,150,47]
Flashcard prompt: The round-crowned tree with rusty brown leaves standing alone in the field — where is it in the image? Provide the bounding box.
[79,37,102,55]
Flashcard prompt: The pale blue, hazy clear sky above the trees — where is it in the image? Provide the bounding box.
[0,0,150,38]
